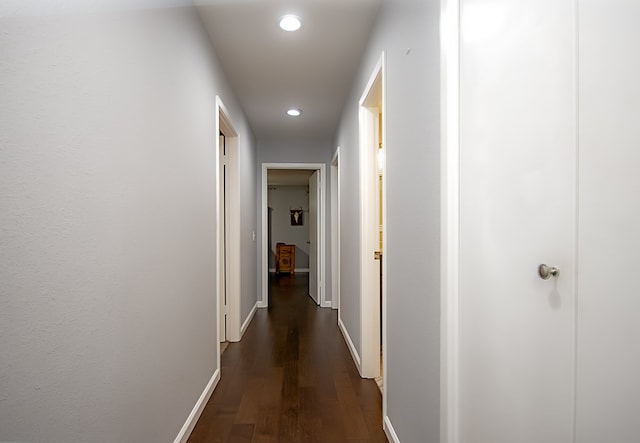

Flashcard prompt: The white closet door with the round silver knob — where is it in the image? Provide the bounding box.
[459,0,576,443]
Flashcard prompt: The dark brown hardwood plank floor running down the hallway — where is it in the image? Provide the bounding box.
[189,274,387,443]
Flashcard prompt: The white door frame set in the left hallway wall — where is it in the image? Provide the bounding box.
[215,96,241,350]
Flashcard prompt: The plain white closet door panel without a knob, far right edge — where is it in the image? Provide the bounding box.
[576,0,640,443]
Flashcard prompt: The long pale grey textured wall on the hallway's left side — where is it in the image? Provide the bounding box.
[0,9,255,442]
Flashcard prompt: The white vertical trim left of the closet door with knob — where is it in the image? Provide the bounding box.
[440,0,460,443]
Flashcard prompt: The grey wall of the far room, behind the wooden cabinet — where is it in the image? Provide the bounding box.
[268,186,309,269]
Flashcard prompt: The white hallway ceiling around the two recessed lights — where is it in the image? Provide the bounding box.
[195,0,381,140]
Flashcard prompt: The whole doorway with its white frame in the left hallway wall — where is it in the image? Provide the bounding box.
[216,97,241,358]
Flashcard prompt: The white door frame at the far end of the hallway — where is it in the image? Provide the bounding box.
[258,163,331,308]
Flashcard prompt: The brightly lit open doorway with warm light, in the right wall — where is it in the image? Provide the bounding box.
[359,53,386,390]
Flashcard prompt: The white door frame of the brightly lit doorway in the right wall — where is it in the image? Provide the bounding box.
[359,52,388,386]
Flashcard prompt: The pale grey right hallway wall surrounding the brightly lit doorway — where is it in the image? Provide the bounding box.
[335,0,440,443]
